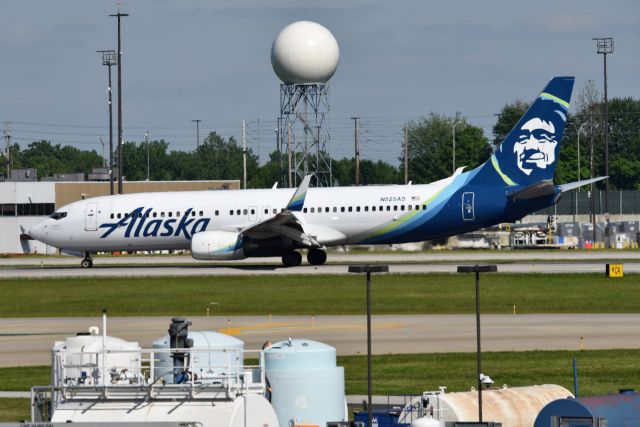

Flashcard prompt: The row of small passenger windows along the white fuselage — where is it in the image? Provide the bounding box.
[111,205,420,219]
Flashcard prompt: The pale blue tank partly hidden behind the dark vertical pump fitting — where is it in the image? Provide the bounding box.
[153,331,244,384]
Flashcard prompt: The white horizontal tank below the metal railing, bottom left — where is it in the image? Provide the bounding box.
[51,394,279,427]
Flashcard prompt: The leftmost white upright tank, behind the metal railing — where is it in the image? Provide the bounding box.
[51,331,141,385]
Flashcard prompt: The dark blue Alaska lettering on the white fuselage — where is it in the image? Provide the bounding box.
[100,206,211,240]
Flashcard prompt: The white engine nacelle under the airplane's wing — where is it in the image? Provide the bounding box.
[191,231,247,260]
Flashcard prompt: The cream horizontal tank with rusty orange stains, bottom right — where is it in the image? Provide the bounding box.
[398,384,573,427]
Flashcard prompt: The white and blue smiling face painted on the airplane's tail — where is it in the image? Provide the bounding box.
[513,117,558,175]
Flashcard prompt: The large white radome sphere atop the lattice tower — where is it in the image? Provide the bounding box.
[271,21,340,84]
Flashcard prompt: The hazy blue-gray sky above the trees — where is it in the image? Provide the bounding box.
[0,0,640,163]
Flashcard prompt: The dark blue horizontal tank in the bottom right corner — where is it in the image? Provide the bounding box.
[534,390,640,427]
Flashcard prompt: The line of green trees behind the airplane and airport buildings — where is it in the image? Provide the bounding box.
[5,81,640,189]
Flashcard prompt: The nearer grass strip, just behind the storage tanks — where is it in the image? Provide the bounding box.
[0,349,640,396]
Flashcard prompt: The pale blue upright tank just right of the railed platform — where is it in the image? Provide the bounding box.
[264,339,347,426]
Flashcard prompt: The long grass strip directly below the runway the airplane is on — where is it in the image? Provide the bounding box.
[0,274,640,317]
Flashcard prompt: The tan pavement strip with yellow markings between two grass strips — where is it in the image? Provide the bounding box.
[0,314,640,366]
